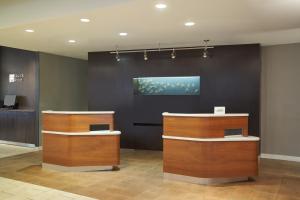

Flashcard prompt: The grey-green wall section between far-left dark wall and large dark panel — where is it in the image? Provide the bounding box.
[39,53,88,143]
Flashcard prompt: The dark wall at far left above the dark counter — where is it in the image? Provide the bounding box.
[0,47,38,110]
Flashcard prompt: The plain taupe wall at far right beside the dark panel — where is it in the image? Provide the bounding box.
[261,44,300,157]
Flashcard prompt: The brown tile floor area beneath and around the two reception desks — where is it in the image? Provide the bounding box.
[0,150,300,200]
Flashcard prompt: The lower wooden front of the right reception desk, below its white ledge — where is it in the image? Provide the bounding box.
[163,139,258,184]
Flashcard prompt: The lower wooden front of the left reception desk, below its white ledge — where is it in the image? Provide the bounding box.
[43,132,120,171]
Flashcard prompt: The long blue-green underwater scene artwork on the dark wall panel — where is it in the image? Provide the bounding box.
[133,76,200,95]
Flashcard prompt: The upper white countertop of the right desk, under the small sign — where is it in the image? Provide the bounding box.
[162,112,249,117]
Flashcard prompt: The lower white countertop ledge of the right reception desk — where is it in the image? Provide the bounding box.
[162,135,259,142]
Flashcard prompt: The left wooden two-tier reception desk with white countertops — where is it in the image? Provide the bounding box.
[42,111,121,171]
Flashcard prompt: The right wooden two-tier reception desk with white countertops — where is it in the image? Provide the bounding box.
[163,113,259,184]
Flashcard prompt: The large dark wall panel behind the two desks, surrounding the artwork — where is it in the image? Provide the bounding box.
[88,44,261,149]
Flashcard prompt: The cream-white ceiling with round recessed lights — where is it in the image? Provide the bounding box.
[0,0,300,59]
